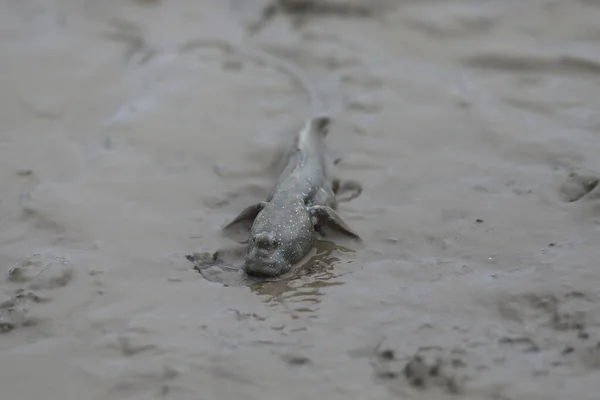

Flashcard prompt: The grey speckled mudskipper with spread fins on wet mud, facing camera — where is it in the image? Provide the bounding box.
[223,116,360,277]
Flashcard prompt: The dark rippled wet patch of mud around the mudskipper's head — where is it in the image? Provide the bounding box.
[187,240,354,317]
